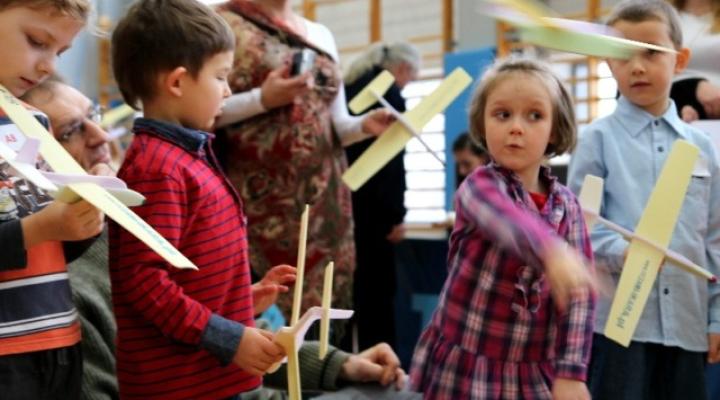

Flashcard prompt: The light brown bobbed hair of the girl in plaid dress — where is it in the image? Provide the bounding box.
[468,57,577,157]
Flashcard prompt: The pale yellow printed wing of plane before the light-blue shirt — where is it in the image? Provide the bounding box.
[605,140,700,347]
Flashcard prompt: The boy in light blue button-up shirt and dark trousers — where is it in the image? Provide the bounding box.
[569,0,720,400]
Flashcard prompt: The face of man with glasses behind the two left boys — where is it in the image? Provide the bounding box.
[40,83,110,170]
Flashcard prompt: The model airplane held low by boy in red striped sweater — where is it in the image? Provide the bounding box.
[268,205,353,400]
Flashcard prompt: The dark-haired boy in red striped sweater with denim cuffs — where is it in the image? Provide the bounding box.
[110,0,283,399]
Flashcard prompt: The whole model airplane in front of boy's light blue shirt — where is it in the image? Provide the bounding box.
[580,140,717,347]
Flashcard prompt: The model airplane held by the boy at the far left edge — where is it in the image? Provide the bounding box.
[0,86,197,269]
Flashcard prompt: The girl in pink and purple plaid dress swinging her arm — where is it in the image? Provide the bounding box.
[410,59,593,399]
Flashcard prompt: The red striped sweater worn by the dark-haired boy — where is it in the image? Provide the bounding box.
[110,132,261,399]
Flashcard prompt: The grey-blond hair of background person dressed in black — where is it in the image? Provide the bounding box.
[343,42,420,85]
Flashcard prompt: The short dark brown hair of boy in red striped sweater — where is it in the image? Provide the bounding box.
[112,0,235,108]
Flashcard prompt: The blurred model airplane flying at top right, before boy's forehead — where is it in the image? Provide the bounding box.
[481,0,676,59]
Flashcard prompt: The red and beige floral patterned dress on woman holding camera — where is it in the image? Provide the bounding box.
[218,0,355,317]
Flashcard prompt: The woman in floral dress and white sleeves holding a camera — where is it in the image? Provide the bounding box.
[216,0,393,343]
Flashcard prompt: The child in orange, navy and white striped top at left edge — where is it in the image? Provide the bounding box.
[0,0,103,399]
